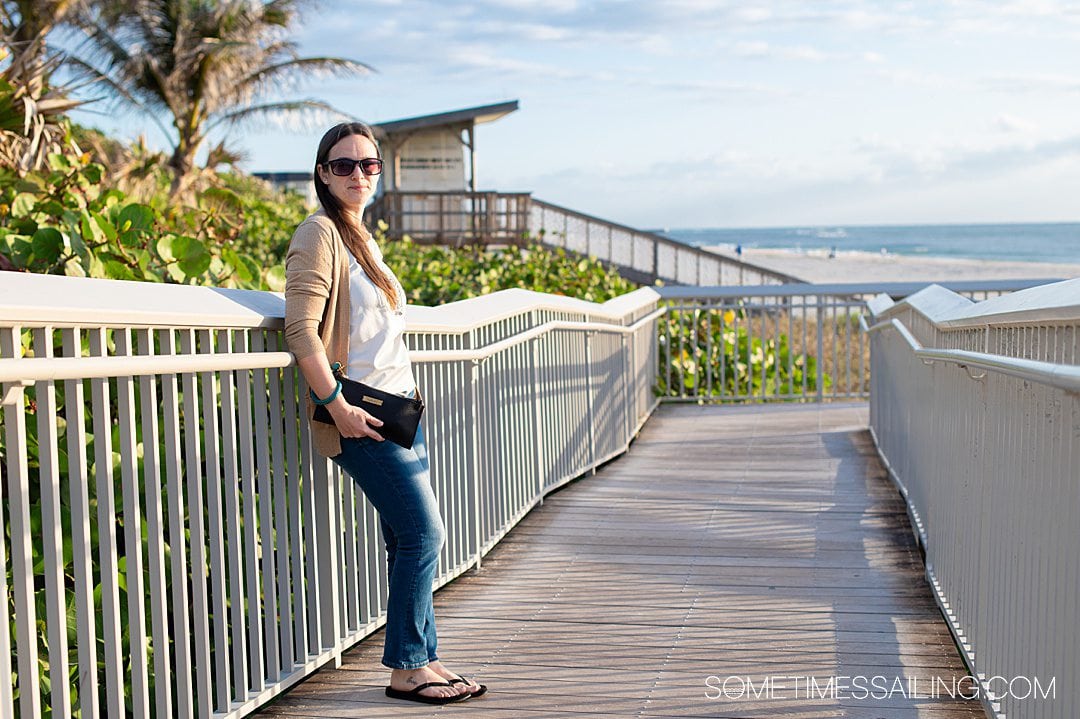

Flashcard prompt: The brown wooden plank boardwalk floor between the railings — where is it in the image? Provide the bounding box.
[265,404,984,719]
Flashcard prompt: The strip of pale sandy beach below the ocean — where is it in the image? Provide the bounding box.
[706,246,1080,283]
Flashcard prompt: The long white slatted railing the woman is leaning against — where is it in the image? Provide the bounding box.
[0,273,662,718]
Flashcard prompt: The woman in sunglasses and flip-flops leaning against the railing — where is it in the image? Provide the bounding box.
[285,122,486,704]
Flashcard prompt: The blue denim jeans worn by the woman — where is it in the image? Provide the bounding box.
[334,429,446,669]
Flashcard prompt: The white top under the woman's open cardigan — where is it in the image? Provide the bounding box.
[345,240,416,394]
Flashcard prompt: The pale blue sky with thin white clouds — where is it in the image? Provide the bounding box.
[71,0,1080,228]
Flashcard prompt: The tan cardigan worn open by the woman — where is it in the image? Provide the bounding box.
[285,209,358,457]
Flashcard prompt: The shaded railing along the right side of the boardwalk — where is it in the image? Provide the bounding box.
[863,280,1080,719]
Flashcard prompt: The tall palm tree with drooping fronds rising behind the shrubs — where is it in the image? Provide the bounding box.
[75,0,372,194]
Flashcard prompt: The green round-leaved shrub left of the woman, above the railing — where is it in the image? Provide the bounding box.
[0,136,306,290]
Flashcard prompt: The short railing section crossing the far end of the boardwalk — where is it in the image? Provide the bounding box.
[657,280,1047,402]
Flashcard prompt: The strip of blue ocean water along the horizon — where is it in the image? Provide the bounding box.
[661,222,1080,263]
